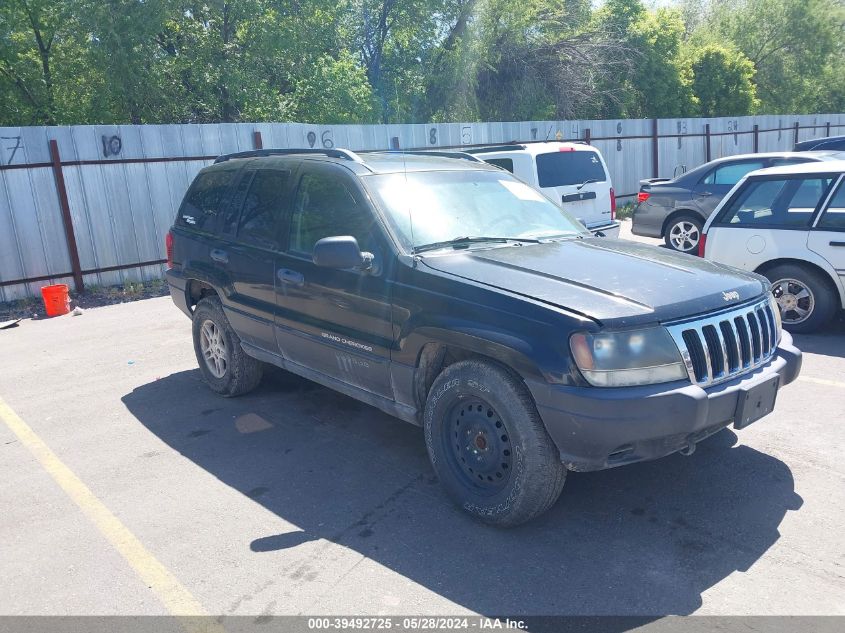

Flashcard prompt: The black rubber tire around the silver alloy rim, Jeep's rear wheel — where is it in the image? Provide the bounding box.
[193,297,264,397]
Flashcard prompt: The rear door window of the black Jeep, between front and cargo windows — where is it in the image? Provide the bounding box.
[238,169,290,248]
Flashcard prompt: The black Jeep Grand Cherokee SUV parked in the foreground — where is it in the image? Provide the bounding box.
[167,149,801,525]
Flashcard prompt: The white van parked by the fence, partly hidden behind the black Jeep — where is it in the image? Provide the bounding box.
[464,141,619,237]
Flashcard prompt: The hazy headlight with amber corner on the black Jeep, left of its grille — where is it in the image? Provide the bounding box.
[569,326,689,387]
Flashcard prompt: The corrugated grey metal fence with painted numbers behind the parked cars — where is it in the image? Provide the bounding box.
[0,114,845,301]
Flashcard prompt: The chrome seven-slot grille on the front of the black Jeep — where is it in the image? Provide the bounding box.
[666,299,780,387]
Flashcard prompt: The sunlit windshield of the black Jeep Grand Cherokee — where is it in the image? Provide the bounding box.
[366,170,586,251]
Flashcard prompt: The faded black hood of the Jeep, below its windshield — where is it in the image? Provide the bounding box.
[422,237,767,326]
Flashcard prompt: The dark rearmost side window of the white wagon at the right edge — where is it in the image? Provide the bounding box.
[721,176,833,227]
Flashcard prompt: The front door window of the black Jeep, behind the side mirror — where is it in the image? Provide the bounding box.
[290,173,375,255]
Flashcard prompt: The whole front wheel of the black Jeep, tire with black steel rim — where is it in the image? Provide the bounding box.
[423,360,566,527]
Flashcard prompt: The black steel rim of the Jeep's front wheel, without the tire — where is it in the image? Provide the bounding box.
[443,397,513,495]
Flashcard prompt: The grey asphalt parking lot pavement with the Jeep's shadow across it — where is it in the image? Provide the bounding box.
[0,225,845,617]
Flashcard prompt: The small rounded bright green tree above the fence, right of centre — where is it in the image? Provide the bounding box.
[690,44,759,117]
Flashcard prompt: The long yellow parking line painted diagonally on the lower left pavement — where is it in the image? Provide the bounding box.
[0,398,224,633]
